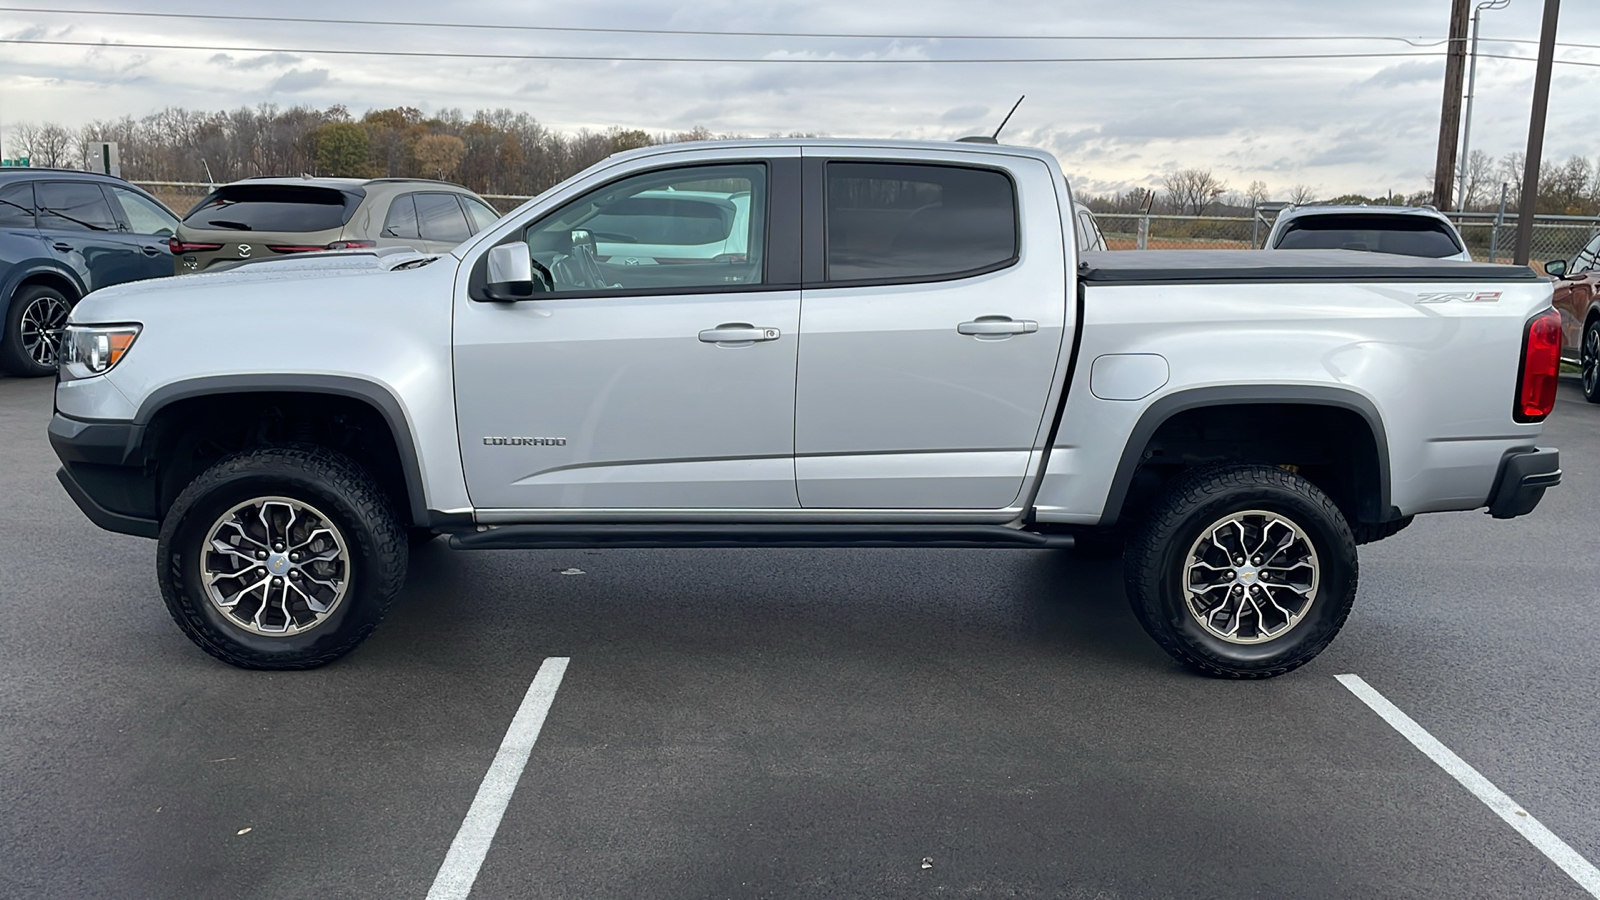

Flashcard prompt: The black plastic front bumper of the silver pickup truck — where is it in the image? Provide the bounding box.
[50,413,162,538]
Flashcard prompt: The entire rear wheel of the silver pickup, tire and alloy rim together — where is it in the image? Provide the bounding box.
[1123,466,1358,679]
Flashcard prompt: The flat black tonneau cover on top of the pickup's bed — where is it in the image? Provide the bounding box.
[1078,250,1541,285]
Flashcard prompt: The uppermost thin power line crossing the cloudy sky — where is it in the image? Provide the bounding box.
[0,6,1445,46]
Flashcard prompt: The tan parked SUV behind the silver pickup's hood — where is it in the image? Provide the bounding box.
[171,178,499,275]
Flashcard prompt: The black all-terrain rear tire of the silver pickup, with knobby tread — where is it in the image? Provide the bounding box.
[1123,466,1358,679]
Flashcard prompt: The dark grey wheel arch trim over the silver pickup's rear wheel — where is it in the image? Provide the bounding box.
[1099,384,1400,527]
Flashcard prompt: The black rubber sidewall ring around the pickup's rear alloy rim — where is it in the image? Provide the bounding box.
[1134,470,1358,677]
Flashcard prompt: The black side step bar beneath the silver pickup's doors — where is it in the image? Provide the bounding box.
[450,524,1072,549]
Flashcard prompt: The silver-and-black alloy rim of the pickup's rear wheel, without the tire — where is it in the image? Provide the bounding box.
[1184,509,1320,644]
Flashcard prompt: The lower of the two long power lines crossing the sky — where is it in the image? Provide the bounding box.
[0,38,1459,66]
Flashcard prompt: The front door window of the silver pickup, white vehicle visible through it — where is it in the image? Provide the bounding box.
[525,163,766,293]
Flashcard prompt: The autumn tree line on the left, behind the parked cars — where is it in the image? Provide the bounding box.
[5,104,768,195]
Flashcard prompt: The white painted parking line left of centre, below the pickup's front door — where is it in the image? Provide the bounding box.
[427,657,570,900]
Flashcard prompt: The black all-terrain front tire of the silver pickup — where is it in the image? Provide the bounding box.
[155,445,408,669]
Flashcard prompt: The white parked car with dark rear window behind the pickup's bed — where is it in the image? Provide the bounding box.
[1266,207,1472,263]
